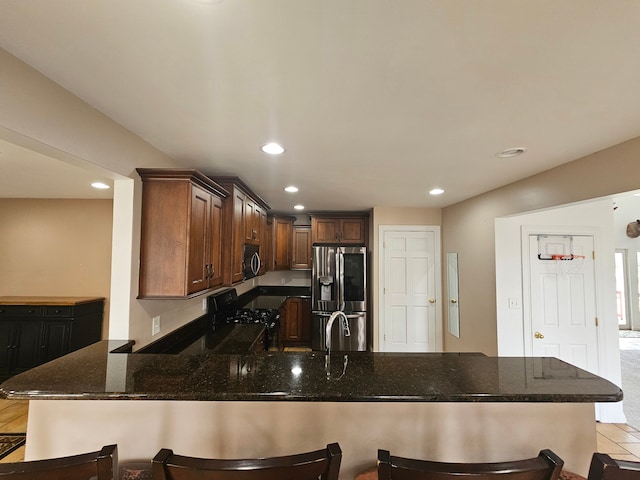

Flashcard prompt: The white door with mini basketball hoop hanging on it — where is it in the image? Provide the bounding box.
[525,235,598,373]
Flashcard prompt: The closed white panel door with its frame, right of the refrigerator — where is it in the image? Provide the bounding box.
[379,227,442,352]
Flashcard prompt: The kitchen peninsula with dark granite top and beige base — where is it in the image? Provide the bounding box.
[0,341,622,479]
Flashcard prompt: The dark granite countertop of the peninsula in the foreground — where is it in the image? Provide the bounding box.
[0,341,622,402]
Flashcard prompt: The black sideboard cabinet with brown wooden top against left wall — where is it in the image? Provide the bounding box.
[0,297,104,380]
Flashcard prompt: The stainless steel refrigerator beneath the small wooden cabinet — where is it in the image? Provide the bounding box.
[311,245,368,351]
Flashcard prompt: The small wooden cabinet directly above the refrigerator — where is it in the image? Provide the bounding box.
[311,214,368,245]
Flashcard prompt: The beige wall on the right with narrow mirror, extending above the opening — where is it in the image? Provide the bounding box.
[442,134,640,355]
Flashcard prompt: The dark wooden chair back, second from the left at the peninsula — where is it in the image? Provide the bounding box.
[151,443,342,480]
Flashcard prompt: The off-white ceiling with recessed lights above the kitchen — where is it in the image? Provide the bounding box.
[0,0,640,212]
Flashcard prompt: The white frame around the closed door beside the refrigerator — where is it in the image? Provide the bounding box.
[373,225,443,352]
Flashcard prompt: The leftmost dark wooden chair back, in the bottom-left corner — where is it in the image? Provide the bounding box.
[0,445,118,480]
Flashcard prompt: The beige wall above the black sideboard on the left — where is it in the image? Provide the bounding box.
[0,198,113,338]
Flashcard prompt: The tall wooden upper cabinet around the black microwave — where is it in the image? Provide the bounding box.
[212,177,270,285]
